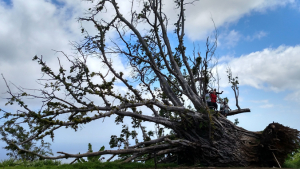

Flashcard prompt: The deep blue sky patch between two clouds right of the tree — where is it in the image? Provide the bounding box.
[218,6,300,54]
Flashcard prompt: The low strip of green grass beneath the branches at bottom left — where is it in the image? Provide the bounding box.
[0,159,177,169]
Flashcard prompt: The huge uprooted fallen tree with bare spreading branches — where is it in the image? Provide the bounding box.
[0,0,300,166]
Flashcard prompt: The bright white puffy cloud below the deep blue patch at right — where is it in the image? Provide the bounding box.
[218,46,300,92]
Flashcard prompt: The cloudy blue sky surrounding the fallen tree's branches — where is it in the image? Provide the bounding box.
[0,0,300,163]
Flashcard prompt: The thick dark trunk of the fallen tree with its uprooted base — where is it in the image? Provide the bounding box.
[170,116,300,167]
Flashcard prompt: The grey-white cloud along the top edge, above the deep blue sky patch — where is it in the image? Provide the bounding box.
[168,0,295,41]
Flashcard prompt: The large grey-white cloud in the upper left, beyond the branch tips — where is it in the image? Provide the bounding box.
[0,0,131,109]
